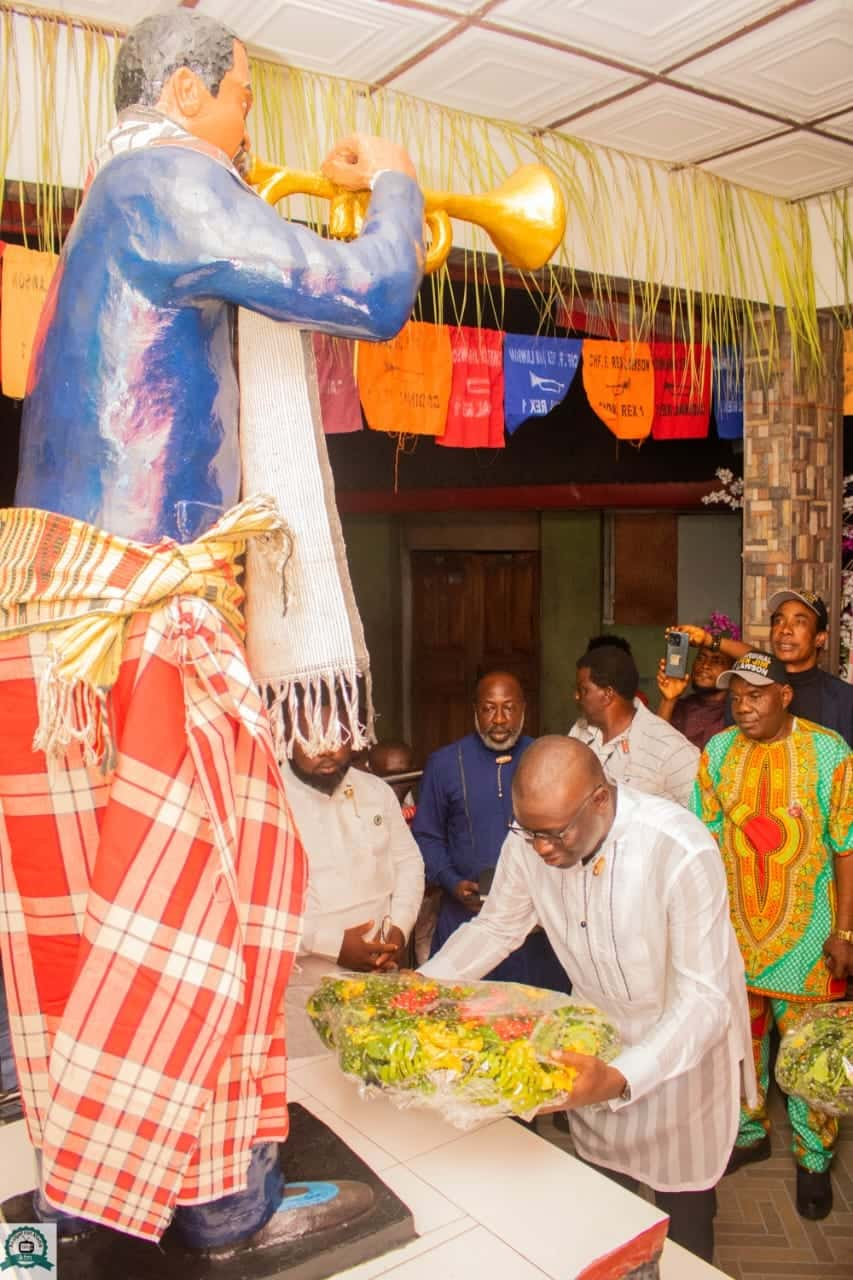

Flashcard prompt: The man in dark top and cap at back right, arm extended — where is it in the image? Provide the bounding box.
[672,588,853,746]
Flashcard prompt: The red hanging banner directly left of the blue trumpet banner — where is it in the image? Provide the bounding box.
[435,325,505,449]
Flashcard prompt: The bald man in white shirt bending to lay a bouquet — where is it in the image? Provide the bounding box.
[421,736,754,1261]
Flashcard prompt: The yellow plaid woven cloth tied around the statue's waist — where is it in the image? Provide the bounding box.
[0,494,291,763]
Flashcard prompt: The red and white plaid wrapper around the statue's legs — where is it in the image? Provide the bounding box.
[0,512,306,1240]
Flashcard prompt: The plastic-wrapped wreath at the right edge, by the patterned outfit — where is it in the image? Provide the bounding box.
[776,1002,853,1116]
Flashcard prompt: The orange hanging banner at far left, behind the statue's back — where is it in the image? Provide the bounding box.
[0,244,59,399]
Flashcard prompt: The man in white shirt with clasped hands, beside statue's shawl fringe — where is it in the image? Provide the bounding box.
[286,716,424,1059]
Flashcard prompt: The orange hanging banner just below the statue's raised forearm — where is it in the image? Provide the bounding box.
[357,320,453,435]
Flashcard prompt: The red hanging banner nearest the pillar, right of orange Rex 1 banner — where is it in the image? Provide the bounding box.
[652,342,711,440]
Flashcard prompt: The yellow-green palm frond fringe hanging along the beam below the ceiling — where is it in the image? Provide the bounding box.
[0,0,853,372]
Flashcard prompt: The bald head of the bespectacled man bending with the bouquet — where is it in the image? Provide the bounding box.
[512,735,616,868]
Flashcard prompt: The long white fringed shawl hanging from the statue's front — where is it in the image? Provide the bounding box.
[238,310,374,760]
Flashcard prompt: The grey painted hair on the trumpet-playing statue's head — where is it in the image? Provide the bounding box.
[114,9,240,111]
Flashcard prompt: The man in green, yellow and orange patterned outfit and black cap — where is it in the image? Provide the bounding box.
[692,650,853,1220]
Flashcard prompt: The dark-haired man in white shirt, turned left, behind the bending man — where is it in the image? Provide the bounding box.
[570,645,699,808]
